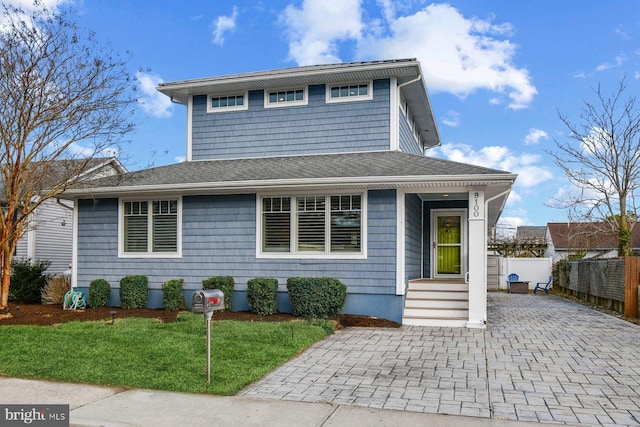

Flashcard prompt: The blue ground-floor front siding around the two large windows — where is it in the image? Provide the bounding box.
[77,190,402,321]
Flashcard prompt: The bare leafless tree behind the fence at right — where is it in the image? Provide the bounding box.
[550,78,640,256]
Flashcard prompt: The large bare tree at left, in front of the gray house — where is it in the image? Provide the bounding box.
[0,5,135,312]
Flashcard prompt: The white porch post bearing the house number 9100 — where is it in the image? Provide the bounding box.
[467,189,487,329]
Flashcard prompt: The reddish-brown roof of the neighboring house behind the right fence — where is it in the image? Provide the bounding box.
[547,222,640,250]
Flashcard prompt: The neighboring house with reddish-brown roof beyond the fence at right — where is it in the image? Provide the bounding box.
[547,222,640,262]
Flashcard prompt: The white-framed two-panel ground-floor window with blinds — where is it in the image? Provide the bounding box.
[118,198,182,257]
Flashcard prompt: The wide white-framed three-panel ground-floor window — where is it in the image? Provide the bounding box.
[257,194,366,258]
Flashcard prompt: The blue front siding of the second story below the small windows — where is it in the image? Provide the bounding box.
[192,80,390,160]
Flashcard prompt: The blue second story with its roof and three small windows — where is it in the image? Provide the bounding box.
[158,59,440,160]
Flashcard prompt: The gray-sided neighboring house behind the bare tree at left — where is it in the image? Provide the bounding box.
[14,157,126,274]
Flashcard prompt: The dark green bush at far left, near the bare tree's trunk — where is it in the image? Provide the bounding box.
[9,258,51,304]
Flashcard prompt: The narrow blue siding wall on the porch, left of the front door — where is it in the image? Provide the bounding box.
[404,194,422,280]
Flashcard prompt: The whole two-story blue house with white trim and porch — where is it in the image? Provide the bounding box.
[65,59,516,328]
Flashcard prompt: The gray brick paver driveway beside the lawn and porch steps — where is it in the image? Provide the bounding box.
[242,293,640,425]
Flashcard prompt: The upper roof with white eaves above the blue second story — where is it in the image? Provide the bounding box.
[157,59,440,146]
